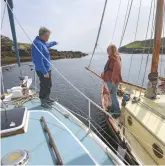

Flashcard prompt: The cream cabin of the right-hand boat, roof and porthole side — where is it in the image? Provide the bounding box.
[118,83,165,165]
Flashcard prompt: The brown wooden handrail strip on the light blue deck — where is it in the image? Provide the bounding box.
[40,116,63,165]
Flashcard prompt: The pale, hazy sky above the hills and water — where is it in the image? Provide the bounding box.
[1,0,164,52]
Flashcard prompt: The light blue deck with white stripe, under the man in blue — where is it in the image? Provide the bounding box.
[1,99,120,165]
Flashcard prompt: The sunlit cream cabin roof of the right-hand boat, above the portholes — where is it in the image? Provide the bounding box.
[126,95,165,145]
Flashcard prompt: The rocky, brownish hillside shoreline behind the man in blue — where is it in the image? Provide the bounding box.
[1,35,87,65]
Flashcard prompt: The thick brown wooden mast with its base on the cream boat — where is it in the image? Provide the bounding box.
[145,0,164,99]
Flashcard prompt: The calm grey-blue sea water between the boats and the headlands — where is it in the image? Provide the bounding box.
[3,54,165,121]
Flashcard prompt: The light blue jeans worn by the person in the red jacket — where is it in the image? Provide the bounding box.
[106,81,120,114]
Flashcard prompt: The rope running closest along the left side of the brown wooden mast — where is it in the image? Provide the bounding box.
[139,0,156,98]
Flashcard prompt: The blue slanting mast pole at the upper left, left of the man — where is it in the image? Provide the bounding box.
[4,0,21,67]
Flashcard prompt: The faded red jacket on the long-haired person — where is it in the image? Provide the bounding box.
[102,55,122,84]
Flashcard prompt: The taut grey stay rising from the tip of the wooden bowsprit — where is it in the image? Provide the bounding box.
[88,0,107,68]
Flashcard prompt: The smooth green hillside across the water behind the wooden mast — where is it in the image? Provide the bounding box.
[119,37,165,54]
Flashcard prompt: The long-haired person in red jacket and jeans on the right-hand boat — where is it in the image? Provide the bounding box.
[101,44,122,117]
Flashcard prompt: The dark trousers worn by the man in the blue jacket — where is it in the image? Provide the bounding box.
[36,71,52,99]
